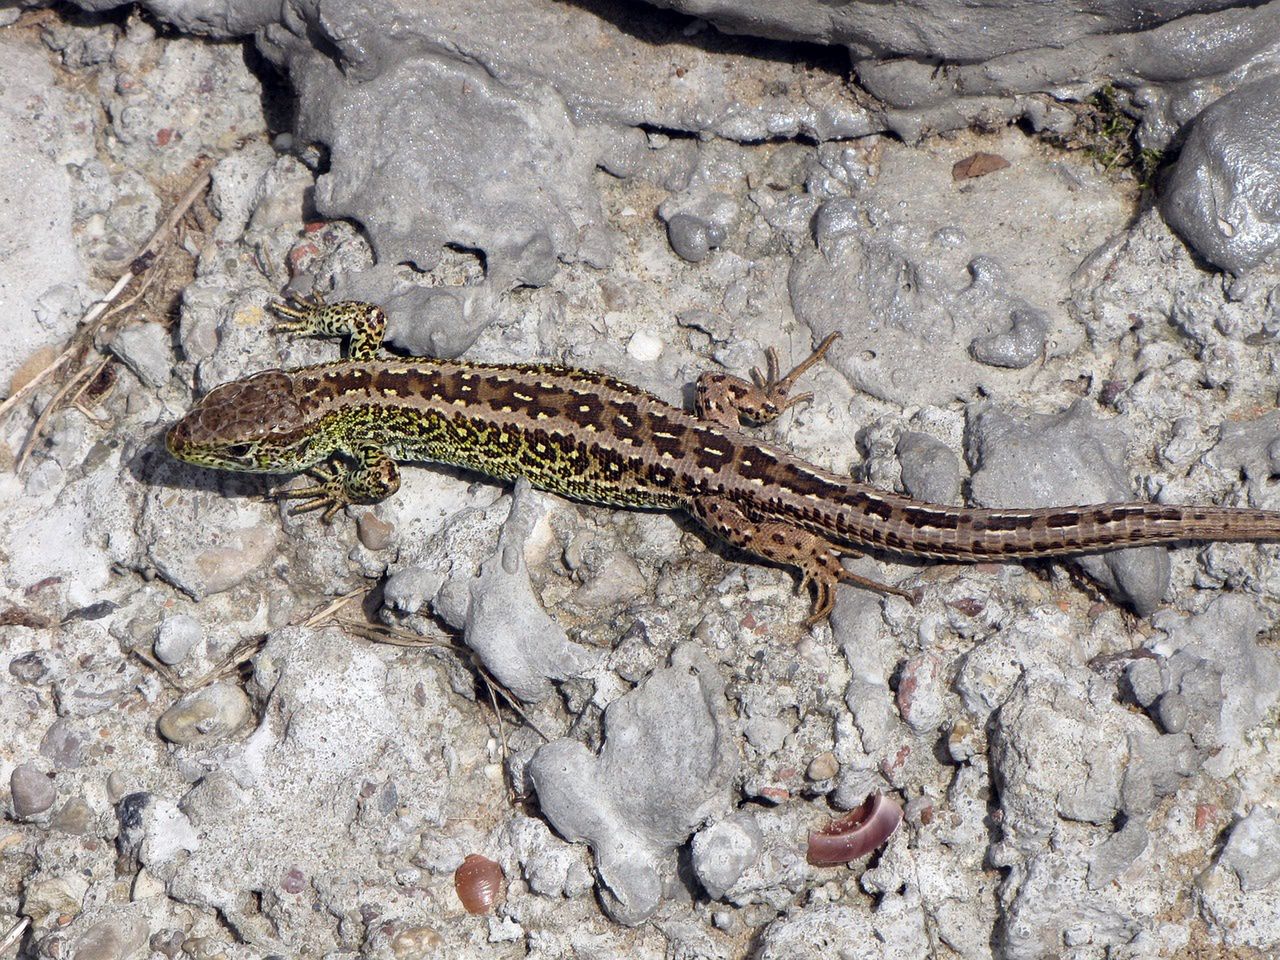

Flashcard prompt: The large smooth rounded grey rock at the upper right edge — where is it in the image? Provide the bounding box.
[1160,76,1280,274]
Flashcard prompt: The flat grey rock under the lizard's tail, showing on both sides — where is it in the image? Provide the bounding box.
[969,402,1170,616]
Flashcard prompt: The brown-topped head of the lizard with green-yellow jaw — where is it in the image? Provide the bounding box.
[165,370,325,474]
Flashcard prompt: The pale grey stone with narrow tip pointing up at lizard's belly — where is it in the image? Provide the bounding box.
[438,479,596,703]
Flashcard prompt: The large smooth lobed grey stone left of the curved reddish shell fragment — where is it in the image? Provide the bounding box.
[529,645,737,924]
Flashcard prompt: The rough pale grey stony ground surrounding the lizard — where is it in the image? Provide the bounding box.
[0,0,1280,960]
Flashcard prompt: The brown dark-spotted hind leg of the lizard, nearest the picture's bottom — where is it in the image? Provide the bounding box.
[686,497,916,626]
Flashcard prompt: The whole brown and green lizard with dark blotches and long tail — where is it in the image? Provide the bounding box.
[165,300,1280,625]
